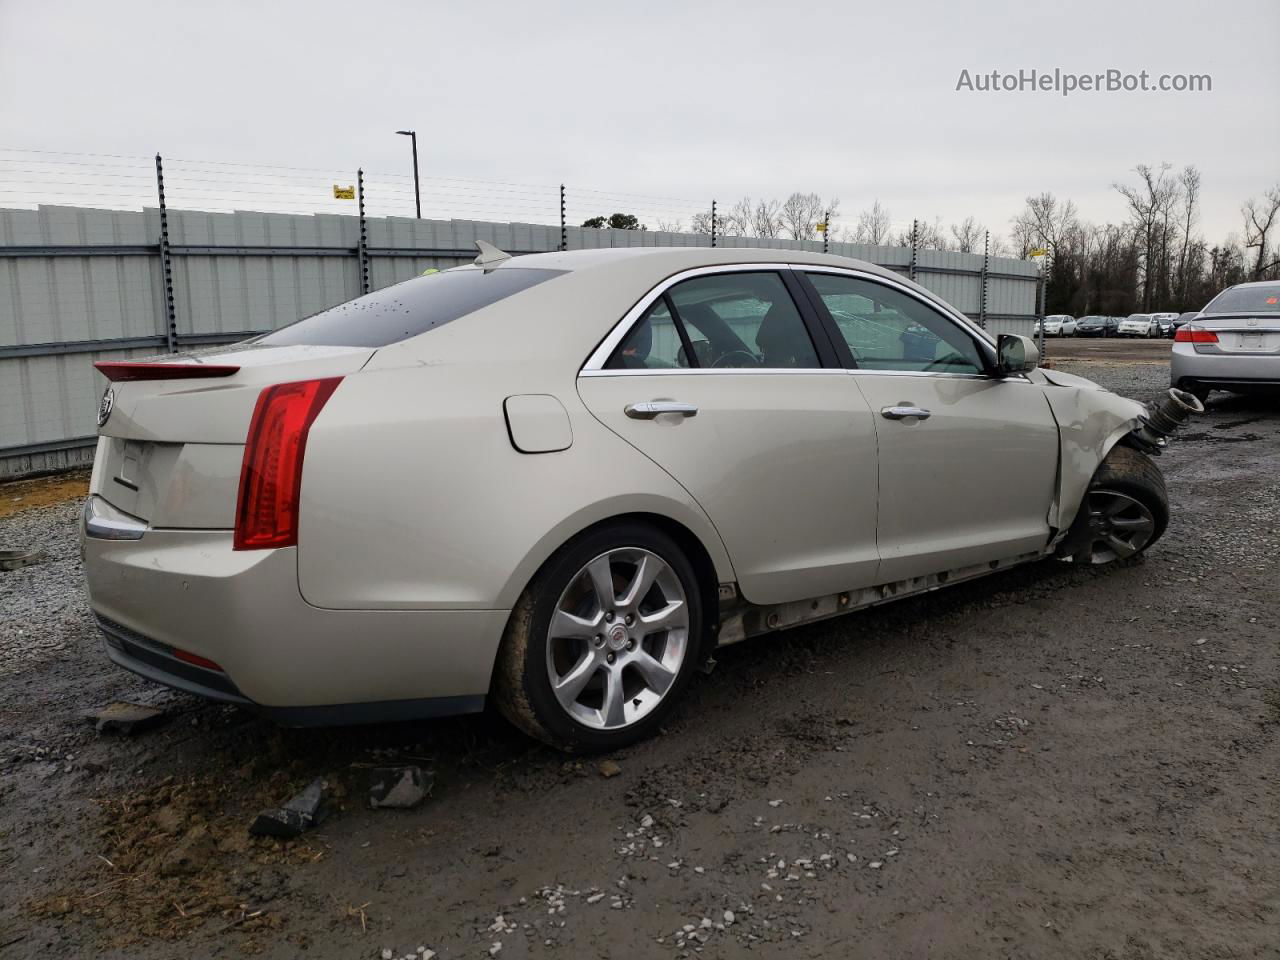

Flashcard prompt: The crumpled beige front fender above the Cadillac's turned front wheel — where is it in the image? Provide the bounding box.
[1030,370,1146,538]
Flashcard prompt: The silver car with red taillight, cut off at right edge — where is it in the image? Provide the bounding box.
[1170,280,1280,401]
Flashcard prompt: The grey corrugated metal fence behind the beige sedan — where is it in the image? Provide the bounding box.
[0,206,1039,479]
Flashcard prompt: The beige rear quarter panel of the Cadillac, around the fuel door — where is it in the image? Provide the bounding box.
[298,364,733,609]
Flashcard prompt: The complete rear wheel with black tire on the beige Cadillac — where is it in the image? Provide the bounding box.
[494,524,703,753]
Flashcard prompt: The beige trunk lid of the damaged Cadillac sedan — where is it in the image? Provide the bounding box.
[90,343,375,529]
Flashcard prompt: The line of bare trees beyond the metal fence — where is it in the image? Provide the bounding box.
[582,163,1280,316]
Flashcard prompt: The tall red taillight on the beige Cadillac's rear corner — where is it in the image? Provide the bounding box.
[233,376,342,550]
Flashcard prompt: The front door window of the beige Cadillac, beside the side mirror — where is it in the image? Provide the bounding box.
[808,274,984,374]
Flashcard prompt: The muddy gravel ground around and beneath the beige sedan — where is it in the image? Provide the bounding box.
[0,355,1280,960]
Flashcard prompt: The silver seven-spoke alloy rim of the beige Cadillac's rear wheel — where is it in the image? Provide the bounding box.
[547,547,689,730]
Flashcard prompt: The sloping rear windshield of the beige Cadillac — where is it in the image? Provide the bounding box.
[256,266,564,347]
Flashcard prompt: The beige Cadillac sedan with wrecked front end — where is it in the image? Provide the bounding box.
[83,244,1198,750]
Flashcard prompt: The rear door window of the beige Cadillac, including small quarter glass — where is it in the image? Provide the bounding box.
[605,271,822,370]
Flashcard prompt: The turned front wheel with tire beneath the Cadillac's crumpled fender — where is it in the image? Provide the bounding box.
[1059,447,1169,566]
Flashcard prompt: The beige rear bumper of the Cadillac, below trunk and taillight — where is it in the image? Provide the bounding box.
[82,530,508,724]
